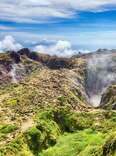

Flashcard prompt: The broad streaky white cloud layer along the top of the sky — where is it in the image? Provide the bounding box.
[0,0,116,23]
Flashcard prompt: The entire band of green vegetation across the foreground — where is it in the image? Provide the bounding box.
[0,107,116,156]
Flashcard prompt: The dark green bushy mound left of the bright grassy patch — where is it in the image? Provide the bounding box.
[25,108,60,154]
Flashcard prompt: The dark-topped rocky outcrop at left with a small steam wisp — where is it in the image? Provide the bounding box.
[0,49,42,87]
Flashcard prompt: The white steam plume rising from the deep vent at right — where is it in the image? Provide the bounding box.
[86,53,116,107]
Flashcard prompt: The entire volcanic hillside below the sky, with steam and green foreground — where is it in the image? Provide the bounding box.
[0,48,116,156]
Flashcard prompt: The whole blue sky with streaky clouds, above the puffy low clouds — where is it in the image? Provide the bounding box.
[0,0,116,54]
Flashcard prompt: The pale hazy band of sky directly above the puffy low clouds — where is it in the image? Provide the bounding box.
[0,29,116,52]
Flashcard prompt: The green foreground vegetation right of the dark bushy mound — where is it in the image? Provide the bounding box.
[39,109,116,156]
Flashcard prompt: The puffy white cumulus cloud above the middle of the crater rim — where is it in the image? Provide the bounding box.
[33,40,77,57]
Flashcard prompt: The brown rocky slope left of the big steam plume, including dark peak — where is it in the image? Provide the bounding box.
[0,49,90,124]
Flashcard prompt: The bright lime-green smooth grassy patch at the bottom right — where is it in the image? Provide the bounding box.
[40,129,105,156]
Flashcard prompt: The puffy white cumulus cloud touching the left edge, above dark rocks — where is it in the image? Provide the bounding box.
[0,36,23,51]
